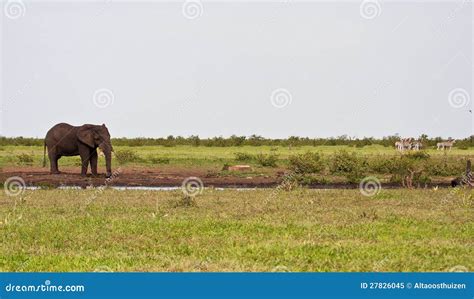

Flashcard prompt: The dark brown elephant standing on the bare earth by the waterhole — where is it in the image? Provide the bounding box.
[43,123,113,178]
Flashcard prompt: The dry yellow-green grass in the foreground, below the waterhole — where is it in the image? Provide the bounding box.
[0,188,474,271]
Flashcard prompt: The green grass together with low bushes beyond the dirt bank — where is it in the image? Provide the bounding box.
[0,145,474,187]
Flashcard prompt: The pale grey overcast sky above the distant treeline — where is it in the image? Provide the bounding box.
[0,0,474,138]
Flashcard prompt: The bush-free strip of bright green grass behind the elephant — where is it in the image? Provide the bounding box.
[0,145,474,167]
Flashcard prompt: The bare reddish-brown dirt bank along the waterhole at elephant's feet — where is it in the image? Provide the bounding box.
[0,167,450,189]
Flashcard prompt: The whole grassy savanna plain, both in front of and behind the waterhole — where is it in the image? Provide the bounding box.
[0,145,474,272]
